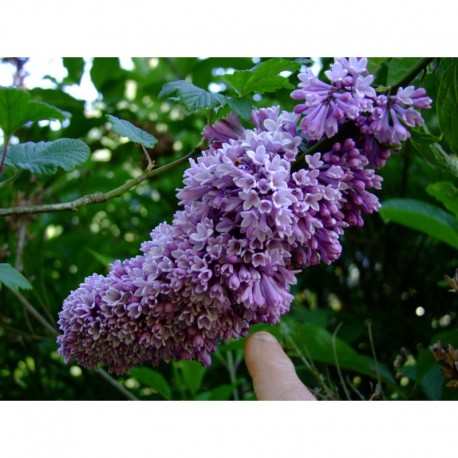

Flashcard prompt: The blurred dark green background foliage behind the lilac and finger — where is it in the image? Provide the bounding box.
[0,58,458,400]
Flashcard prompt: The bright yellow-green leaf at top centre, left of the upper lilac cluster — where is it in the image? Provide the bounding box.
[223,58,301,96]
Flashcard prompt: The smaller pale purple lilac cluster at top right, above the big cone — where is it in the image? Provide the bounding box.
[291,58,431,167]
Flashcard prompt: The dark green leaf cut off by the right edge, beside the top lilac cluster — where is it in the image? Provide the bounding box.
[436,60,458,153]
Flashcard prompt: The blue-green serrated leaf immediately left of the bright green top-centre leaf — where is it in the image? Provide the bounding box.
[158,80,227,112]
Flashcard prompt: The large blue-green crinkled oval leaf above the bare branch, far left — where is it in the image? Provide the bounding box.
[5,138,90,175]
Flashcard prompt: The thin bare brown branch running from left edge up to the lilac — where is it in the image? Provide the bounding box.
[0,140,204,216]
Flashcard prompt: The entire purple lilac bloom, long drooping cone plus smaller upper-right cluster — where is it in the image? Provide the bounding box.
[58,59,430,373]
